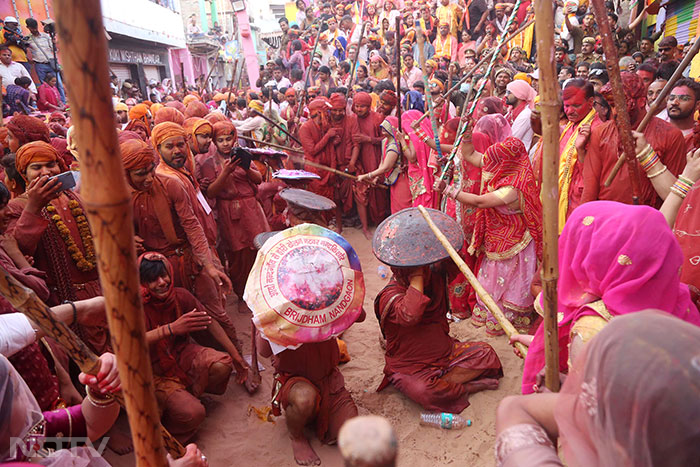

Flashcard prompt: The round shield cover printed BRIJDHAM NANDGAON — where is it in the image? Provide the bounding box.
[243,224,365,349]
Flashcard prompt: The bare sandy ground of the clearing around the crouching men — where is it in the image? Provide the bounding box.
[101,229,522,467]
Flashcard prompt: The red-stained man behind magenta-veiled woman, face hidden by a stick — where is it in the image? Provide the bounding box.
[581,72,686,207]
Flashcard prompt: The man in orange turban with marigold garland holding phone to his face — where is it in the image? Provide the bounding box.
[8,143,111,354]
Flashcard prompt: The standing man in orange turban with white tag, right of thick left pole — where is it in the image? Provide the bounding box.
[144,122,238,350]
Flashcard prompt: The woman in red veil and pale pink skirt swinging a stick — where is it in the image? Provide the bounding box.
[444,133,542,336]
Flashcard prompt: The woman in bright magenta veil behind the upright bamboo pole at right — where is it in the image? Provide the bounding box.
[522,201,700,394]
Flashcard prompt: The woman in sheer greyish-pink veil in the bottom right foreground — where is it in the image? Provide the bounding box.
[495,310,700,467]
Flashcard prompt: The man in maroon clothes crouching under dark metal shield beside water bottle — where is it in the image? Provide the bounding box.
[374,266,503,413]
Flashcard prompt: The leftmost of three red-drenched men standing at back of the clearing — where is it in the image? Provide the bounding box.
[299,97,342,229]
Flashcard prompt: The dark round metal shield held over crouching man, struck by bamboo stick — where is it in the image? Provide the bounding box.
[372,208,464,267]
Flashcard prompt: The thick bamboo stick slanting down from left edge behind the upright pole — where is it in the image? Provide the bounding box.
[0,265,185,457]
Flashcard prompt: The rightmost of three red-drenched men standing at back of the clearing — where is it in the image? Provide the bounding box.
[352,92,389,224]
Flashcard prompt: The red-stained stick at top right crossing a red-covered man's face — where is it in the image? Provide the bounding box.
[592,0,640,204]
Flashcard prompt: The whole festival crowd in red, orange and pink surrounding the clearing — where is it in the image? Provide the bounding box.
[0,0,700,466]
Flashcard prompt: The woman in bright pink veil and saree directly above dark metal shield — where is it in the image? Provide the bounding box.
[401,110,438,208]
